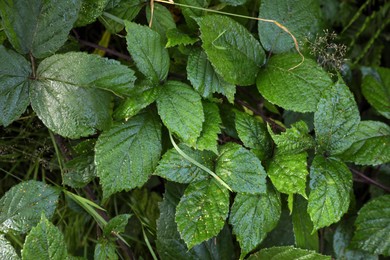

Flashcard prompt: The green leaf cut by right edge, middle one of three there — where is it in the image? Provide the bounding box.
[341,121,390,165]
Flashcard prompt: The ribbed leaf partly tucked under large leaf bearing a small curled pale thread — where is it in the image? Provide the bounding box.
[187,49,236,103]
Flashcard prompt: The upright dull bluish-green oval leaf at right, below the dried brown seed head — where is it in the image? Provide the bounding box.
[314,82,360,155]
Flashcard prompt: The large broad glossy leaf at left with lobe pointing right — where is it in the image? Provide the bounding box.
[30,52,135,138]
